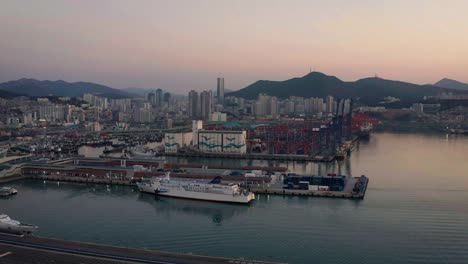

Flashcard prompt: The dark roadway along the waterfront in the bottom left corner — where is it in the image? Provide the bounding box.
[0,233,282,264]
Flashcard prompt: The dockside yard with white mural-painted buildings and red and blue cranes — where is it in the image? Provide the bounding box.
[156,105,377,162]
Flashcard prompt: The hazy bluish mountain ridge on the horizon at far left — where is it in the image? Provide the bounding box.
[0,78,134,98]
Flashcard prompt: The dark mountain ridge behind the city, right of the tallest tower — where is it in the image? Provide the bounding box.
[229,72,468,101]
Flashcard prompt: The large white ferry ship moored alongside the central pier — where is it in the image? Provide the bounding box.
[137,174,255,203]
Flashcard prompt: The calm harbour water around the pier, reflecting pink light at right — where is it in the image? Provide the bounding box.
[0,133,468,264]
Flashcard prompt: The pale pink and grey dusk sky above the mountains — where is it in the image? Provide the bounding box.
[0,0,468,93]
